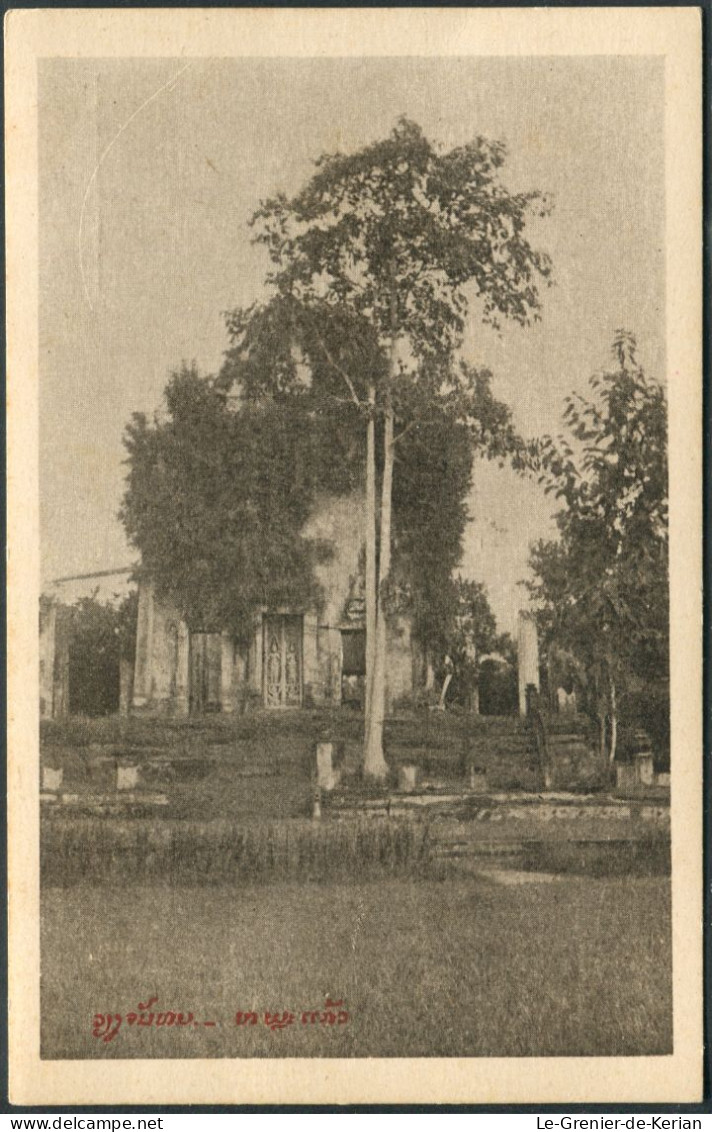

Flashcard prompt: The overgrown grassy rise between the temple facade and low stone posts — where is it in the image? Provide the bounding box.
[41,710,604,824]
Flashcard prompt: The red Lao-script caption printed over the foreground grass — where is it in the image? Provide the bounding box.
[92,995,350,1041]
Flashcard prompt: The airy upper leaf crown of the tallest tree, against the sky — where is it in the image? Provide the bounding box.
[246,118,550,361]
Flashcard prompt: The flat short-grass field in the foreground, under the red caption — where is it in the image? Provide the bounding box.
[42,876,671,1058]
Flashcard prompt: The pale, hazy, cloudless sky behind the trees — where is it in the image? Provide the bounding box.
[40,57,666,629]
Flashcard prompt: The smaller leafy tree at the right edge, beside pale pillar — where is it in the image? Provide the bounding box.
[529,331,669,762]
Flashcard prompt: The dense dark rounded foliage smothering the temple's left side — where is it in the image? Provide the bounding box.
[121,366,341,636]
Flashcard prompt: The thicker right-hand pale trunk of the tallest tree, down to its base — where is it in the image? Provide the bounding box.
[363,401,393,779]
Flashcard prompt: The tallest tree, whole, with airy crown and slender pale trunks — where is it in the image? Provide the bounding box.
[221,119,550,778]
